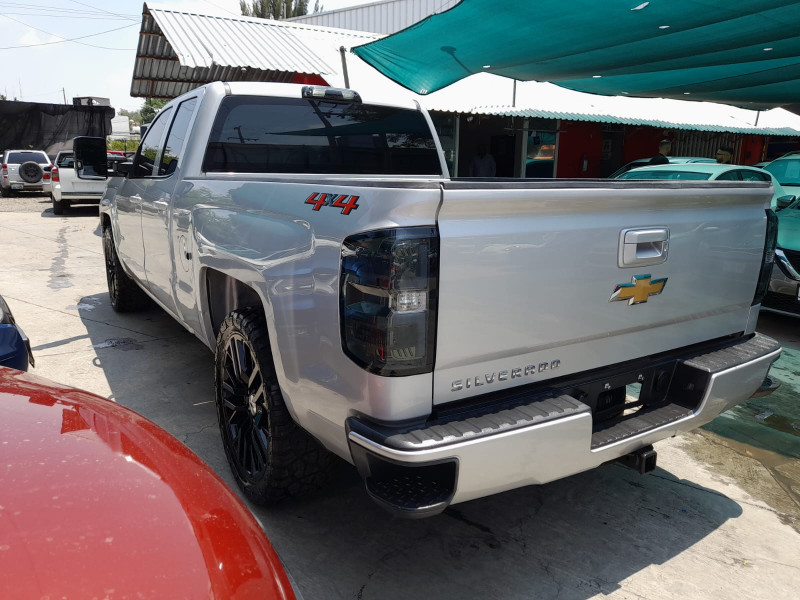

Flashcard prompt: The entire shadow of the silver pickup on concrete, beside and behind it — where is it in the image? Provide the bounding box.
[73,294,742,600]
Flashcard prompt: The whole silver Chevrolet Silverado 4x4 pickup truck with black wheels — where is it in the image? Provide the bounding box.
[75,82,780,516]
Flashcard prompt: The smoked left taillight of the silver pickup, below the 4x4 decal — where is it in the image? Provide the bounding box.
[339,227,439,377]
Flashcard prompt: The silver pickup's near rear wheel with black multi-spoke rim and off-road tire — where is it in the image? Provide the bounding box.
[214,308,331,504]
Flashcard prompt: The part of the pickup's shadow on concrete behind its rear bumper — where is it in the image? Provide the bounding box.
[254,458,742,600]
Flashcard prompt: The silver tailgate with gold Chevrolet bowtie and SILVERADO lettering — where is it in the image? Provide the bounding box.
[434,180,771,404]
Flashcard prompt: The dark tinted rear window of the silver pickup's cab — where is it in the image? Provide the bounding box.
[203,96,441,175]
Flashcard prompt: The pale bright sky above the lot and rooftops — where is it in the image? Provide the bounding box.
[0,0,369,110]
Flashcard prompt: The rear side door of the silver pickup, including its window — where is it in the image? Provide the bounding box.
[142,97,197,314]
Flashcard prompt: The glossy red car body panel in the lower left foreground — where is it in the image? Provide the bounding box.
[0,367,294,599]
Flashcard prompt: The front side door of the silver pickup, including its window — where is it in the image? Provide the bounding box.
[114,108,173,285]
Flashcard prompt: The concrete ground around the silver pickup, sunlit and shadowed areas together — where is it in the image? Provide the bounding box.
[0,197,800,600]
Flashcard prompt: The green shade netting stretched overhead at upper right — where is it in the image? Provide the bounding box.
[352,0,800,109]
